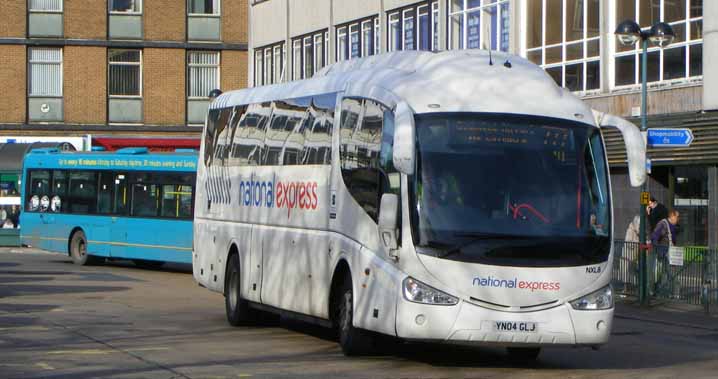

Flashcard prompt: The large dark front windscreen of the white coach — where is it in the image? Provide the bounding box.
[411,113,611,266]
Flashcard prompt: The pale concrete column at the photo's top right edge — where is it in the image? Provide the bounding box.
[703,1,718,110]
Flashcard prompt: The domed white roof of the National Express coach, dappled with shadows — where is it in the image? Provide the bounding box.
[211,50,593,124]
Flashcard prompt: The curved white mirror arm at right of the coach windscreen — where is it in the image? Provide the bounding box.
[593,110,647,187]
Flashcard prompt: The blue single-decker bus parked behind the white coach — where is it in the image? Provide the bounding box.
[20,148,197,267]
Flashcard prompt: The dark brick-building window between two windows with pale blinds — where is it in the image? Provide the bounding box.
[109,50,142,97]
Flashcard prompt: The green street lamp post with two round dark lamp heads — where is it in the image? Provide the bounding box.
[615,20,675,305]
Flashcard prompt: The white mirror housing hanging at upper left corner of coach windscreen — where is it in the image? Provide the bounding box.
[392,101,416,175]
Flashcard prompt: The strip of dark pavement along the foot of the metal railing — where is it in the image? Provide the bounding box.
[615,300,718,332]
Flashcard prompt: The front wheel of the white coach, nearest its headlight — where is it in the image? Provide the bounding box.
[337,280,374,356]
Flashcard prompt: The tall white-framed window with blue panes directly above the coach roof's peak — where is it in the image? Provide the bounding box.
[449,0,512,51]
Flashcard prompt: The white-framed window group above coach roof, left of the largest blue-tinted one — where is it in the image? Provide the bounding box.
[387,1,439,51]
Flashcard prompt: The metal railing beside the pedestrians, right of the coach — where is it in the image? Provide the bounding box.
[613,240,718,312]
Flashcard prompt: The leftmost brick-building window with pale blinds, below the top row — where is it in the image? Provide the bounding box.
[29,47,62,97]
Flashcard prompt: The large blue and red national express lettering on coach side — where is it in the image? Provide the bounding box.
[239,175,319,218]
